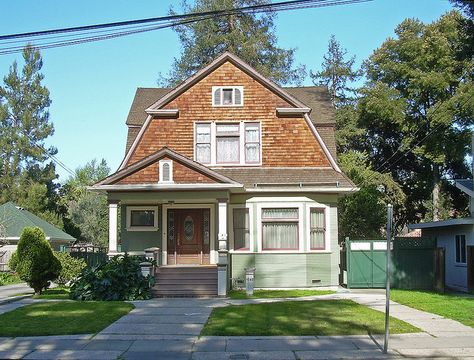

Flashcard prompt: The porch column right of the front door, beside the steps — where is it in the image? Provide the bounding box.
[217,199,228,296]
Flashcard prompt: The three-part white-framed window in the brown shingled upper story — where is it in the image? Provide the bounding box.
[194,122,261,165]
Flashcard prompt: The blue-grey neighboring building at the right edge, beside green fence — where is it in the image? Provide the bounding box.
[408,138,474,291]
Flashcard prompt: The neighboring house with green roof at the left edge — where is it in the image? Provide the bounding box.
[0,202,76,271]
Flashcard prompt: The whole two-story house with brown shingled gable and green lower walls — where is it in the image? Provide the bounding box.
[91,53,357,295]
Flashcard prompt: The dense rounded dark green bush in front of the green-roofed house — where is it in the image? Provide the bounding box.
[9,227,61,294]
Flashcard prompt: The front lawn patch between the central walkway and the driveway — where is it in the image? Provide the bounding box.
[201,300,421,336]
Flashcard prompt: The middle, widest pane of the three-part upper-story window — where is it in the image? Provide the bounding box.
[216,124,240,164]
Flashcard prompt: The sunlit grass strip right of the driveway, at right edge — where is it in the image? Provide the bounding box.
[390,290,474,327]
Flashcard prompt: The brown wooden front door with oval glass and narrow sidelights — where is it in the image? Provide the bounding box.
[168,209,210,265]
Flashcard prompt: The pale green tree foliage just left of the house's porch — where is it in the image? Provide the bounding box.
[61,159,110,246]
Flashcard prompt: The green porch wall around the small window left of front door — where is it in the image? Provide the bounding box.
[120,205,162,252]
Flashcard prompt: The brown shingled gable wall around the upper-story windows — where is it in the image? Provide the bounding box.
[126,61,331,167]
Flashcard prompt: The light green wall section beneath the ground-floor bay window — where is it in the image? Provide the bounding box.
[230,253,337,288]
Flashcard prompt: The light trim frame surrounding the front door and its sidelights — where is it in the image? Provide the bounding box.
[161,204,218,265]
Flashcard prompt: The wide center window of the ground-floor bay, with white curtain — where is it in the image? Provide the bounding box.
[262,208,299,250]
